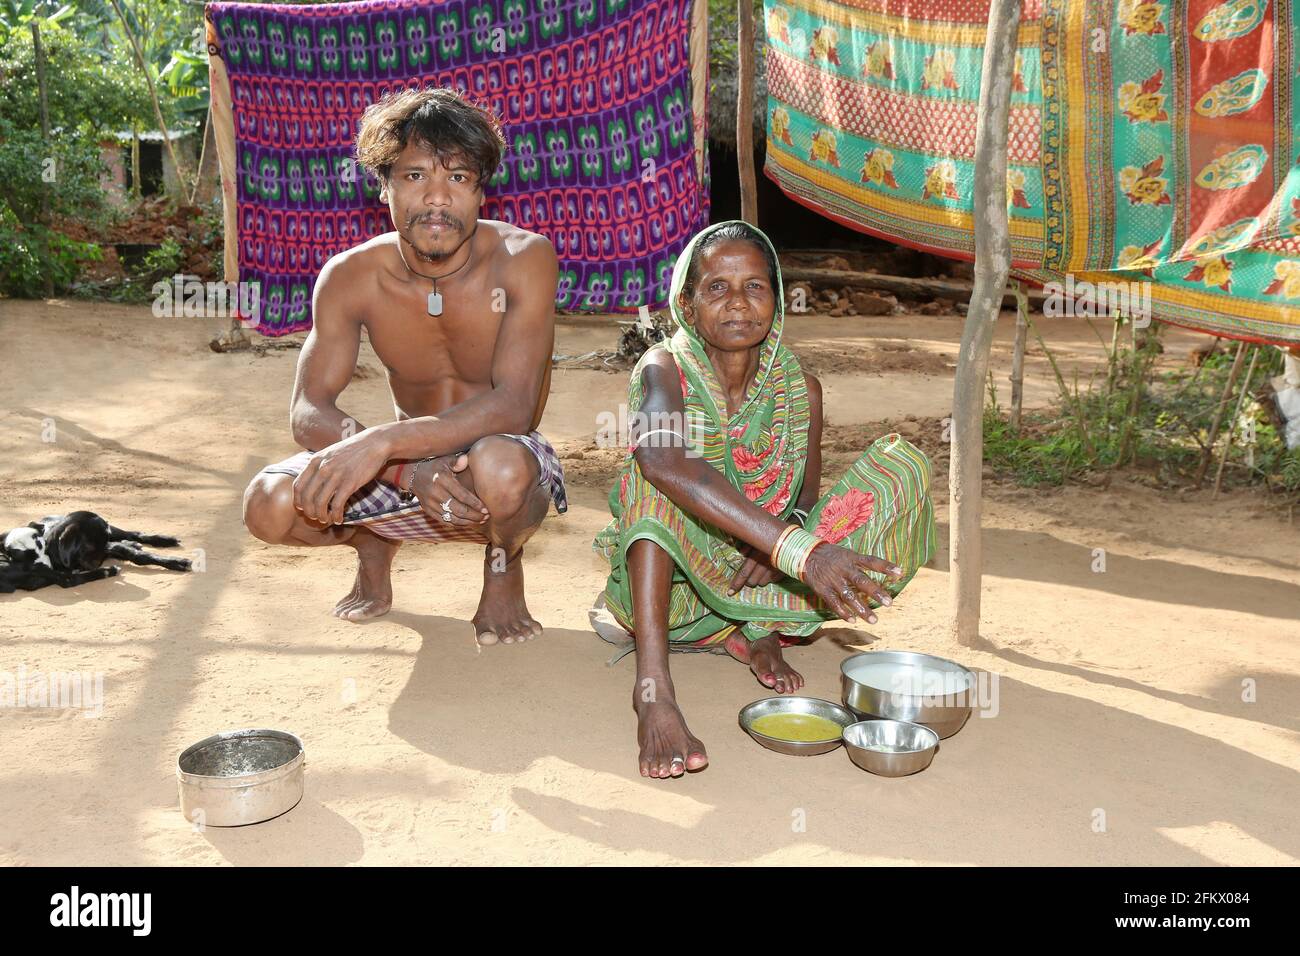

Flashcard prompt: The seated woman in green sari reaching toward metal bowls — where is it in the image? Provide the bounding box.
[595,220,935,777]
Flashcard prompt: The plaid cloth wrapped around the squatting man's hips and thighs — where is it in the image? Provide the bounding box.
[261,432,568,544]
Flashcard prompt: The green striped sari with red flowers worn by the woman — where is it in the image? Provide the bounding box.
[594,222,935,645]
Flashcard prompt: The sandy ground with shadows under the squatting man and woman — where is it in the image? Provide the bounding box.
[0,302,1300,865]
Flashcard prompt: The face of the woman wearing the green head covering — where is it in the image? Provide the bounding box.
[681,239,776,351]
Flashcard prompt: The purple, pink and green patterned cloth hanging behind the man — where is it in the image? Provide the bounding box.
[207,0,709,336]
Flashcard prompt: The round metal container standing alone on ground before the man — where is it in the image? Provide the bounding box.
[176,730,306,826]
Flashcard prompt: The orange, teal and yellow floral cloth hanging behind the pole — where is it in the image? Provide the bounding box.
[764,0,1300,343]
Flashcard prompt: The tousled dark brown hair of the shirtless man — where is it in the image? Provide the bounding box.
[356,87,506,186]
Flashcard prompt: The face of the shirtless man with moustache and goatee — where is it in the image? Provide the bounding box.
[380,142,484,261]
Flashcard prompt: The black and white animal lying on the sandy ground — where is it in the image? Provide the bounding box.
[0,511,190,594]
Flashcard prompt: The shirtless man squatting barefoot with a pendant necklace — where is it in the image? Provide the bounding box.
[243,88,568,645]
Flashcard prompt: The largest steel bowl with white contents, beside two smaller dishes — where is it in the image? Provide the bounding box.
[840,650,975,737]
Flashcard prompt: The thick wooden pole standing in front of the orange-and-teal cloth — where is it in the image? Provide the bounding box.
[948,0,1021,646]
